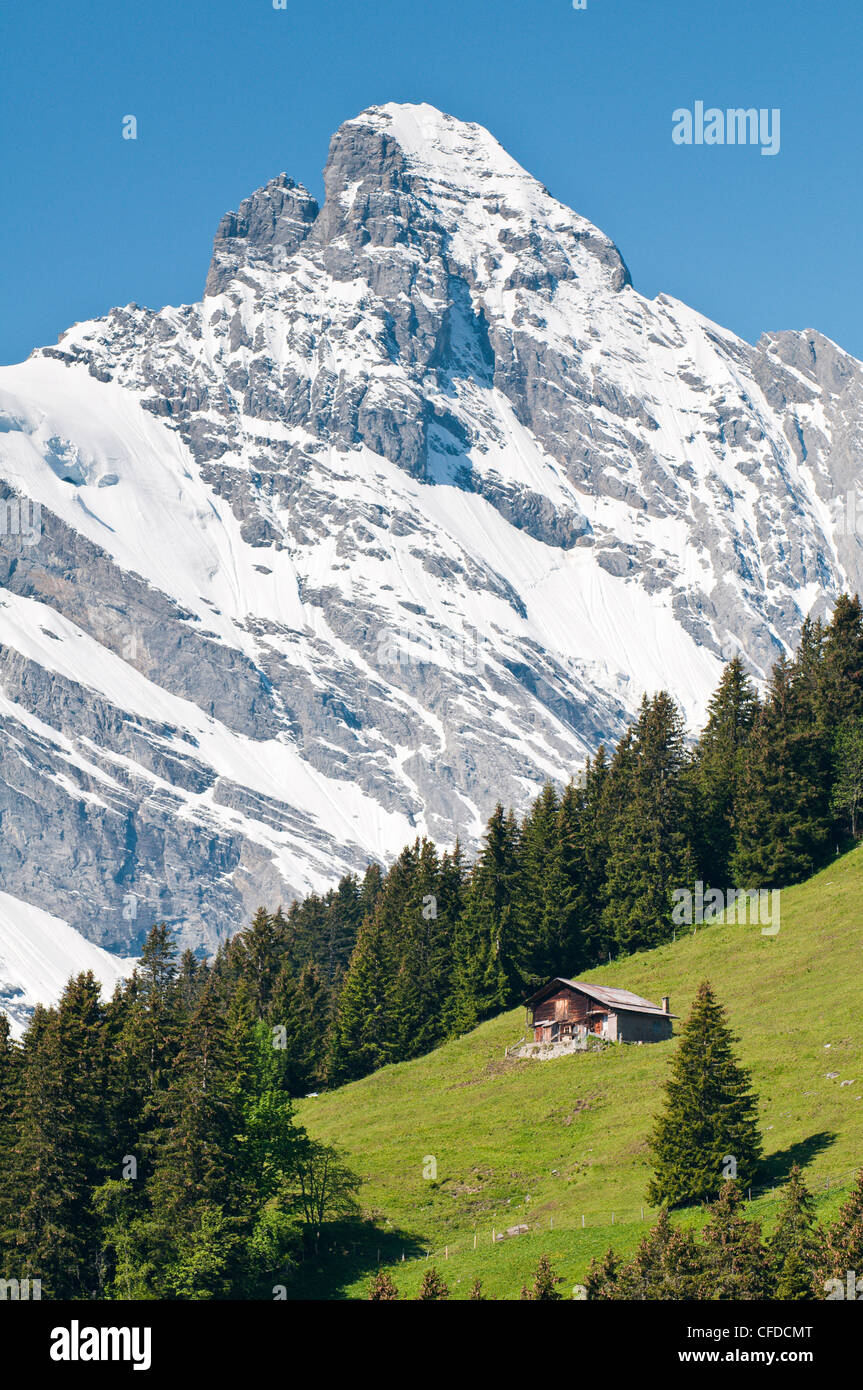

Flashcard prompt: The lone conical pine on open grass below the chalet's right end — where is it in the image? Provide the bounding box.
[648,981,762,1207]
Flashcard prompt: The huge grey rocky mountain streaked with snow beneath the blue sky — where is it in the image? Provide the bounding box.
[0,97,863,1017]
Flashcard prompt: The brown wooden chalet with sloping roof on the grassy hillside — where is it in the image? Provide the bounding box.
[527,977,675,1043]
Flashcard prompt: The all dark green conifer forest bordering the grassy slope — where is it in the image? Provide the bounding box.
[0,598,863,1300]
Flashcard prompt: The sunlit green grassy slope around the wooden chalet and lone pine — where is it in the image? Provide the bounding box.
[299,848,863,1297]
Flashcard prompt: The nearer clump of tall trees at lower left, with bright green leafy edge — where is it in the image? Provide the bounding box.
[0,915,359,1300]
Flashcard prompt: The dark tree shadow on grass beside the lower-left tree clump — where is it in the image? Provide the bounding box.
[285,1222,428,1301]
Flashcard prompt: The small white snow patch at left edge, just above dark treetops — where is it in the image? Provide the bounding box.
[0,892,135,1037]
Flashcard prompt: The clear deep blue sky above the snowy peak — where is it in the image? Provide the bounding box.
[0,0,863,363]
